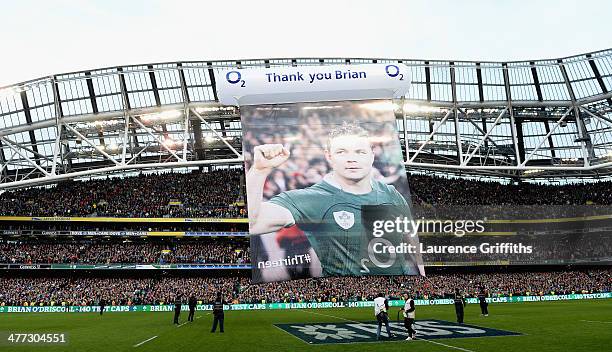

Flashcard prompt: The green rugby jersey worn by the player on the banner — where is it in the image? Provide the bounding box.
[270,181,418,276]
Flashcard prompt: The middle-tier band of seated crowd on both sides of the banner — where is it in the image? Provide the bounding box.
[0,232,612,264]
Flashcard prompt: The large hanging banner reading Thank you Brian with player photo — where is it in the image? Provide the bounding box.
[218,65,424,282]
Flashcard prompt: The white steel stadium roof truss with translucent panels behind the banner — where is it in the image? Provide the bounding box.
[0,50,612,189]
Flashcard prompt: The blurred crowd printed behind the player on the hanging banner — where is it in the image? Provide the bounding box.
[241,101,410,200]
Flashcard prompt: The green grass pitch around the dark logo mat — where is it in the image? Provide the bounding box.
[0,300,612,352]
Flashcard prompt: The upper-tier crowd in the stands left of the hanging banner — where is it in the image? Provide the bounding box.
[0,170,244,218]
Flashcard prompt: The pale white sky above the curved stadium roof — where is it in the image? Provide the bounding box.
[0,0,612,87]
